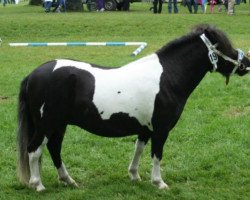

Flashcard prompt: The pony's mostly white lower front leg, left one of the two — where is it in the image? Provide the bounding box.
[128,136,150,181]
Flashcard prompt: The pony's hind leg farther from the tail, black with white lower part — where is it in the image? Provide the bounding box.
[47,129,78,187]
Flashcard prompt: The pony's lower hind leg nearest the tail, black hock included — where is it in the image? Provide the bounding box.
[28,134,48,192]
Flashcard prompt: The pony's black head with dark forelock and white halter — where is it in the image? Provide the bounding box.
[193,24,250,82]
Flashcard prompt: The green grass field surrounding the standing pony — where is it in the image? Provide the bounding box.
[0,2,250,200]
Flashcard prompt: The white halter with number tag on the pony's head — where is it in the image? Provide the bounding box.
[200,33,250,76]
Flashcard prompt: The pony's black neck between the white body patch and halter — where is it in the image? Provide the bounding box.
[157,37,211,98]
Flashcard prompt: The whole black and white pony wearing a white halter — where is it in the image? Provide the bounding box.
[18,25,250,191]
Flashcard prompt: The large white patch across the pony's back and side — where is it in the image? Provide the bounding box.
[53,54,163,130]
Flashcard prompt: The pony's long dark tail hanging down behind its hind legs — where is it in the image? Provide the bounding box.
[17,77,33,184]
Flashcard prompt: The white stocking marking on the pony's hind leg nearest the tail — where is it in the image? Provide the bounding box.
[29,137,48,192]
